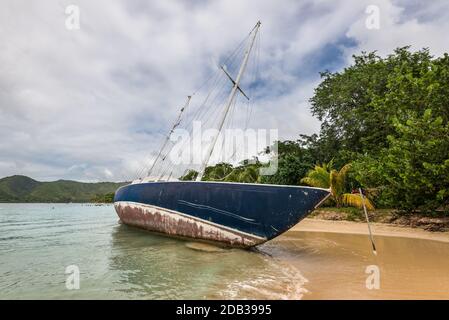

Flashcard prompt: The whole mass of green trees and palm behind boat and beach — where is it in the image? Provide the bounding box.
[183,47,449,214]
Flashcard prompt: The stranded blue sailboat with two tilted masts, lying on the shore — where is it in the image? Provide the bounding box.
[114,21,330,248]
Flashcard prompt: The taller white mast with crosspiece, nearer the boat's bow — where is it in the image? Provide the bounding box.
[196,21,261,181]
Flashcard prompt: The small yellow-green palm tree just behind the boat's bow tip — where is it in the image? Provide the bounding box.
[301,162,374,210]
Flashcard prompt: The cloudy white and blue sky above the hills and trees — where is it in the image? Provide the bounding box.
[0,0,449,181]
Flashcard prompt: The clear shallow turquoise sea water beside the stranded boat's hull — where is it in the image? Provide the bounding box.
[0,204,305,299]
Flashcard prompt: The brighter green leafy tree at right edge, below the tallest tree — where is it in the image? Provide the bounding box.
[355,109,449,211]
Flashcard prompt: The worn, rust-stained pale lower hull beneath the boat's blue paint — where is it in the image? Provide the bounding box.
[114,202,266,247]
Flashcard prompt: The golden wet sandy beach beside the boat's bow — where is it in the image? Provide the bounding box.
[262,219,449,299]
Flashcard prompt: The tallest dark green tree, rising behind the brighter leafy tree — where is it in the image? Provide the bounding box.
[303,47,449,165]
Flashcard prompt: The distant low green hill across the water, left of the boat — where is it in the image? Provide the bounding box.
[0,175,126,202]
